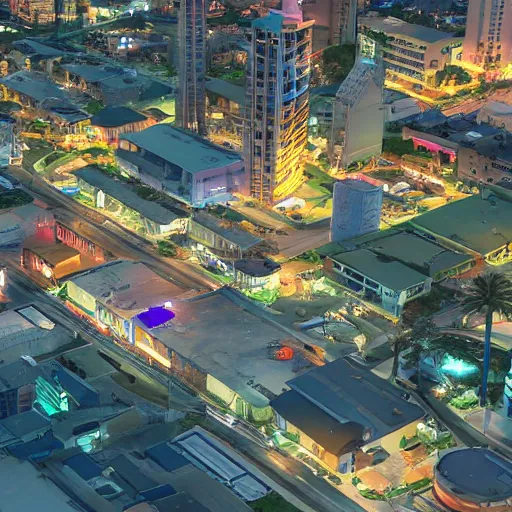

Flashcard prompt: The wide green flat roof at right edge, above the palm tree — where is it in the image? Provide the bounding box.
[410,195,512,255]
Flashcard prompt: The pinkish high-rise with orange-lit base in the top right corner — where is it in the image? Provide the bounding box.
[462,0,512,68]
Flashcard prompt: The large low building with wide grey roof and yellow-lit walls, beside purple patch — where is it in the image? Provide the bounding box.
[129,288,311,422]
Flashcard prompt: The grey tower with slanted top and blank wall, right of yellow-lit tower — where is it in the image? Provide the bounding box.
[329,35,384,169]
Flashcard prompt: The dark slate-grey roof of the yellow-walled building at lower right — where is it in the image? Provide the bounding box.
[287,358,425,440]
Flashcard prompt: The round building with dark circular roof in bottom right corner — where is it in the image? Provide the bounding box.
[434,448,512,512]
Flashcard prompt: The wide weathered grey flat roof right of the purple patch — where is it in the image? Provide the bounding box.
[143,289,308,407]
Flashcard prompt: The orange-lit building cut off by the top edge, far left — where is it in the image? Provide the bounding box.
[9,0,76,25]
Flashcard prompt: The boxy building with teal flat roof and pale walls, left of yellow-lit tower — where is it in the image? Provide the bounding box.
[116,124,248,206]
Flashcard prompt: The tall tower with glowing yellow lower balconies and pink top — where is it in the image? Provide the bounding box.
[244,0,314,204]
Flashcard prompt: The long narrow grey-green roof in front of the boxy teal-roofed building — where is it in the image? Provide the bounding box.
[74,167,178,226]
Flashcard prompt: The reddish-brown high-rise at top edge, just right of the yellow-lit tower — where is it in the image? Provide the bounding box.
[302,0,357,52]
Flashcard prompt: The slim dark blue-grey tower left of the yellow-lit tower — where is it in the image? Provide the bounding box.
[174,0,208,135]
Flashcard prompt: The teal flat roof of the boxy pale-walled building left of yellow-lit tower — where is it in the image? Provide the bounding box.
[121,124,241,173]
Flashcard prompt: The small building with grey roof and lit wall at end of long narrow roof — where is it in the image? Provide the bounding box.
[187,212,263,263]
